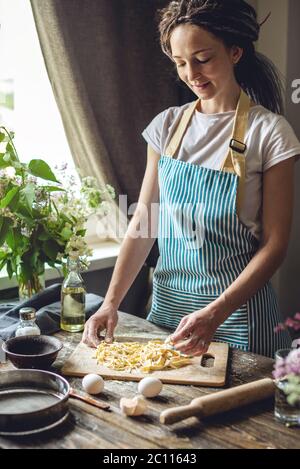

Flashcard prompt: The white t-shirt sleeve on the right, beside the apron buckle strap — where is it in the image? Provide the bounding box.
[263,116,300,172]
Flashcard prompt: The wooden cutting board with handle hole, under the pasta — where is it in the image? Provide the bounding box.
[62,337,229,387]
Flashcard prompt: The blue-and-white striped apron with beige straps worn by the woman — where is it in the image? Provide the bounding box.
[147,91,291,357]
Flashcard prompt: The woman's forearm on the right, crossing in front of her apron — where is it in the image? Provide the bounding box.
[213,244,285,324]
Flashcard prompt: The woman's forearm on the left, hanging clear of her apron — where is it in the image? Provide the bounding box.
[104,217,156,309]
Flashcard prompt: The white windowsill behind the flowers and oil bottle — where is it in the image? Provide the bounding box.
[0,241,121,291]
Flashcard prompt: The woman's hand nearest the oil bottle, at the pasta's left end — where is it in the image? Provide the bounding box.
[82,304,118,347]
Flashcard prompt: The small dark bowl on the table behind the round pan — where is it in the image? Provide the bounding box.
[2,335,63,370]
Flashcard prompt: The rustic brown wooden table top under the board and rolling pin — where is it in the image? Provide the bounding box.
[0,313,300,450]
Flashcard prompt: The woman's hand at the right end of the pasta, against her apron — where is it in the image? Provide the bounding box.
[171,305,220,357]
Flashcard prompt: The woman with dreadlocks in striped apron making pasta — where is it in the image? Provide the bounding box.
[83,0,300,357]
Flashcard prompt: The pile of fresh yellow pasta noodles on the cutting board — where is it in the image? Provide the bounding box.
[96,339,191,373]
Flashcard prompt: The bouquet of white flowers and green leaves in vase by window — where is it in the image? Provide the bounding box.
[0,127,115,299]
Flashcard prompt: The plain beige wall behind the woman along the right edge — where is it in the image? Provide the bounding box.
[253,0,300,316]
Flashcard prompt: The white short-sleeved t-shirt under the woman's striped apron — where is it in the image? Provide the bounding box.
[142,103,300,239]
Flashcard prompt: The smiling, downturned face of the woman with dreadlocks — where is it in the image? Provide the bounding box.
[170,24,242,100]
